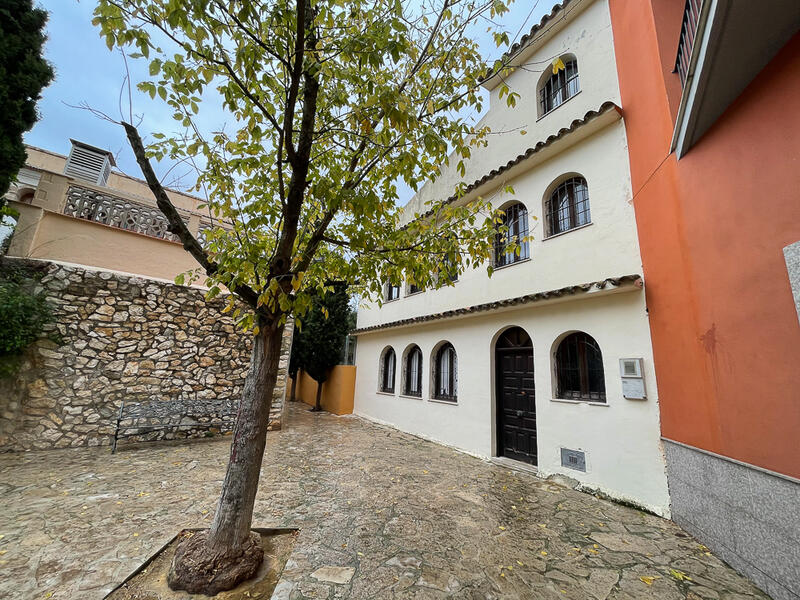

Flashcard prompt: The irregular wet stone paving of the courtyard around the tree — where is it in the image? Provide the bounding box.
[0,405,767,600]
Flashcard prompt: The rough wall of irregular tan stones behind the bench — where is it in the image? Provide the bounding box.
[0,258,292,451]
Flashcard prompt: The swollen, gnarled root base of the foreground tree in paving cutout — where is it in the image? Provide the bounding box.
[167,531,264,596]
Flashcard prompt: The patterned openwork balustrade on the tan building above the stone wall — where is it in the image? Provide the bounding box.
[64,185,188,242]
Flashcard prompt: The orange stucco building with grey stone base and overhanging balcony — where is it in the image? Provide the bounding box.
[609,0,800,599]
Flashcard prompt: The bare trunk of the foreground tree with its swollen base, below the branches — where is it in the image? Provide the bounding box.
[169,322,283,595]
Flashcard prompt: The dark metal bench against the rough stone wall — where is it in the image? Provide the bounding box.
[111,398,238,454]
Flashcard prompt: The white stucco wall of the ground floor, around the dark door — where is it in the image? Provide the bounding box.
[354,289,669,516]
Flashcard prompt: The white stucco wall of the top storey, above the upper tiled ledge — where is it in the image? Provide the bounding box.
[403,0,620,221]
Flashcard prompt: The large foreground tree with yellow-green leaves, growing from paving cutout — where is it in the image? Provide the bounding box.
[94,0,516,594]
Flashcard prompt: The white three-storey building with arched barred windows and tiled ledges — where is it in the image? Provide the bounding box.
[355,0,669,516]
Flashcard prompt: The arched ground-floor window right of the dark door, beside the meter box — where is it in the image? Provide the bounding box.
[556,331,606,402]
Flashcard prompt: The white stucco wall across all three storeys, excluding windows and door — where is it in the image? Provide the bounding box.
[355,0,669,516]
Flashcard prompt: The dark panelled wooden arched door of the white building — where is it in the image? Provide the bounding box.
[494,327,537,465]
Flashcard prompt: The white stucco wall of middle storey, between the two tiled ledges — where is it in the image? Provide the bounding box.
[358,120,642,328]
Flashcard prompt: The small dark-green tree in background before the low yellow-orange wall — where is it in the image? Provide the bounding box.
[290,283,350,411]
